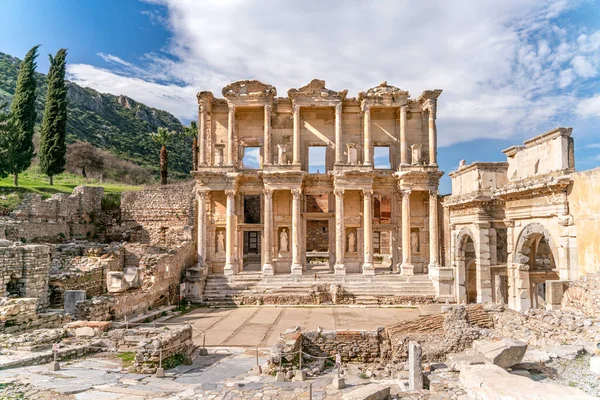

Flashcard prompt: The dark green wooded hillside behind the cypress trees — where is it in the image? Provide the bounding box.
[0,52,194,179]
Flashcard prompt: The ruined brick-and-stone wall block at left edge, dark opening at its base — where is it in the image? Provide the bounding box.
[0,240,50,308]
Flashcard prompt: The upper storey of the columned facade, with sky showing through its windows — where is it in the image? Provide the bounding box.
[197,79,442,173]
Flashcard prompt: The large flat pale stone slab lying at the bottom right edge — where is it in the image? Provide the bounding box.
[459,365,595,400]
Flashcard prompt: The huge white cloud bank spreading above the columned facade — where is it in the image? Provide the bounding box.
[64,0,600,146]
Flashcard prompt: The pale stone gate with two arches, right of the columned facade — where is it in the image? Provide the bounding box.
[444,128,600,310]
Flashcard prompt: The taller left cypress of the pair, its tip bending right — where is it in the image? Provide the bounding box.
[6,45,40,186]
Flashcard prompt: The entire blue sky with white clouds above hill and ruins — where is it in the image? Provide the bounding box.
[0,0,600,193]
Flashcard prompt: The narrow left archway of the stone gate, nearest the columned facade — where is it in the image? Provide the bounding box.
[456,228,477,303]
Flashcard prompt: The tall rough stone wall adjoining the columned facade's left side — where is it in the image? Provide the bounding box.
[121,182,196,245]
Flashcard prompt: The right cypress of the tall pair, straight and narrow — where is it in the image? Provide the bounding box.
[40,49,67,185]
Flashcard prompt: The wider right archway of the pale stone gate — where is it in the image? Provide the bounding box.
[515,223,560,308]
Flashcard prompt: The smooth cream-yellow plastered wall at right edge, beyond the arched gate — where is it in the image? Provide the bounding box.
[568,168,600,276]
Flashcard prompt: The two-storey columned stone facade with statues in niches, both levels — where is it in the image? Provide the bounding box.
[193,79,451,294]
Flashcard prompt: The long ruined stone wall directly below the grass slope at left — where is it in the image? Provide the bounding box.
[0,186,104,242]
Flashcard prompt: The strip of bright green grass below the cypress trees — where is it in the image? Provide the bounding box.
[0,167,142,215]
